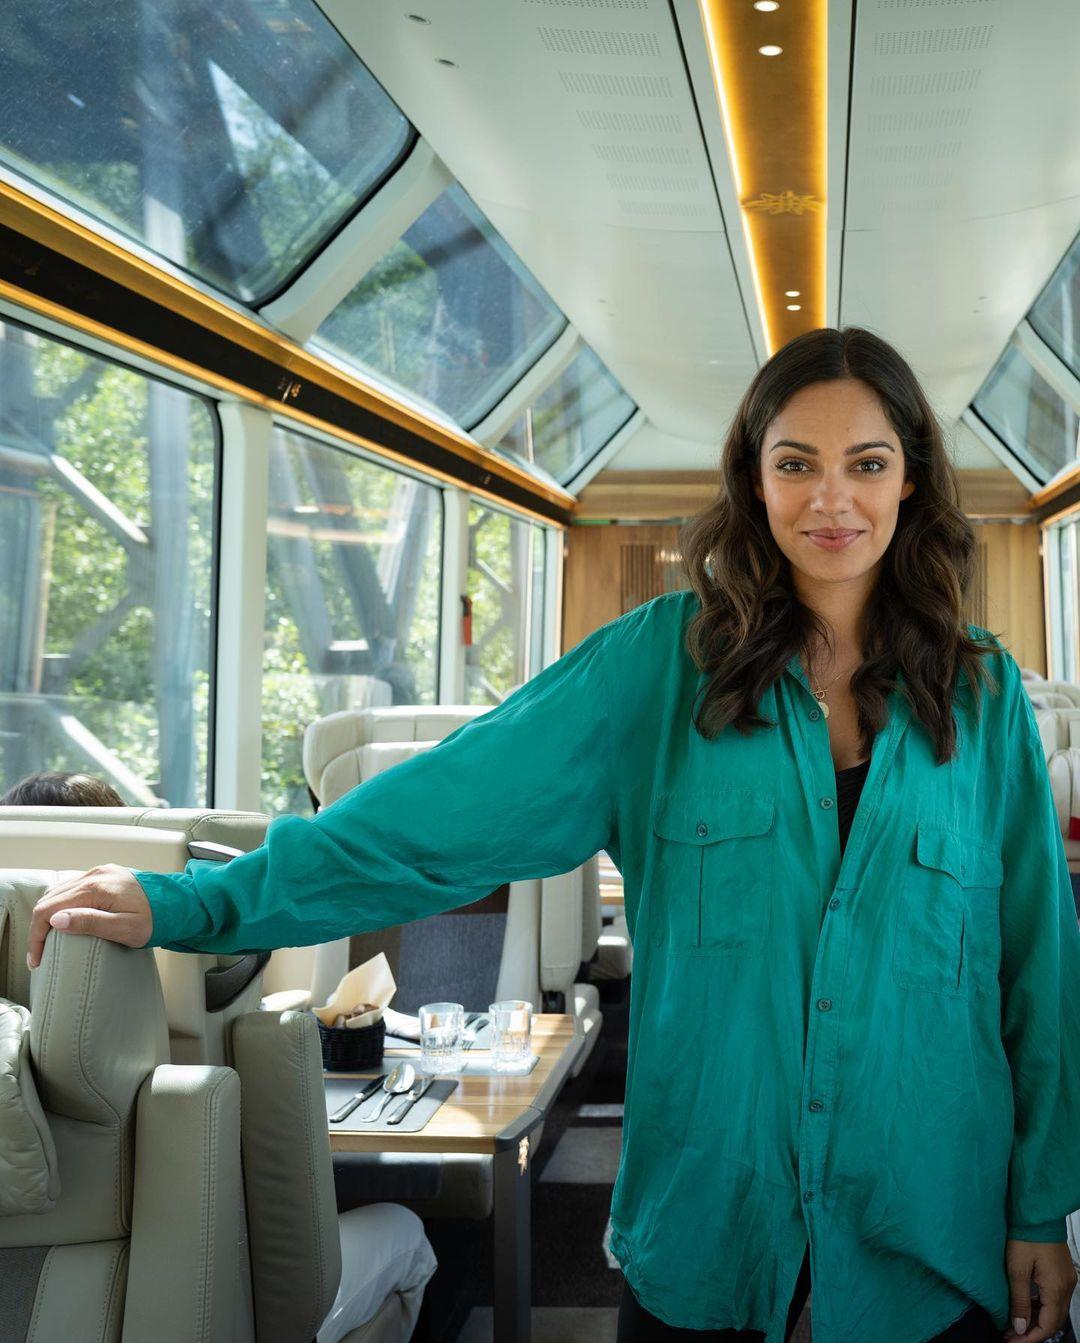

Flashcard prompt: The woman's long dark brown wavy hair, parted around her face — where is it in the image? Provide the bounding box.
[681,326,997,764]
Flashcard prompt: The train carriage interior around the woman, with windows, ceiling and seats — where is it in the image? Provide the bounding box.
[0,0,1080,1343]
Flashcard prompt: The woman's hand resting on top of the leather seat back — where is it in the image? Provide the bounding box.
[27,862,153,970]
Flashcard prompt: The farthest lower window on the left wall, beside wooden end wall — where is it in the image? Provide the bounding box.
[465,500,545,704]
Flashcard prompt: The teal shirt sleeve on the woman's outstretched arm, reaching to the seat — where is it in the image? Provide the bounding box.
[136,622,617,952]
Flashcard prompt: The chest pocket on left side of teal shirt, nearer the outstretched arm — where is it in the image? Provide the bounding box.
[653,788,776,956]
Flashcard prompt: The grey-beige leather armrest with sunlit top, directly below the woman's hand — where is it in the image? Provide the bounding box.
[124,1064,251,1343]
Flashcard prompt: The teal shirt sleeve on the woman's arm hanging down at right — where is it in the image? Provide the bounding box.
[1001,657,1080,1241]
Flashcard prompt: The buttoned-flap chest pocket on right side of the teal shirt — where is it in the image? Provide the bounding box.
[892,821,1002,998]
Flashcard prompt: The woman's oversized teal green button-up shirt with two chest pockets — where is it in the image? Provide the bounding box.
[138,592,1080,1343]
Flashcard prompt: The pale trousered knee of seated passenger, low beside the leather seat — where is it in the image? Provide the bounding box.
[316,1203,438,1343]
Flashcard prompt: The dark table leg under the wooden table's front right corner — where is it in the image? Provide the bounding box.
[492,1133,532,1343]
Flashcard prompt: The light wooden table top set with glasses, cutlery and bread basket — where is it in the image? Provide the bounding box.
[324,1013,583,1154]
